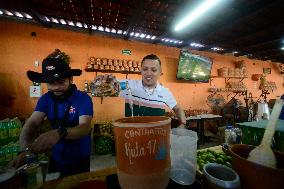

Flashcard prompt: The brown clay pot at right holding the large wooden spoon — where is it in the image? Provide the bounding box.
[230,144,284,189]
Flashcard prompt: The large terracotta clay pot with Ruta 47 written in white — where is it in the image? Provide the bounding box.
[113,116,171,189]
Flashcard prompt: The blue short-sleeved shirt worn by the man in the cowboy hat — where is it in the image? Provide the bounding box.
[35,85,93,165]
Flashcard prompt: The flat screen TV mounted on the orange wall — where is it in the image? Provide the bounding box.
[177,50,213,83]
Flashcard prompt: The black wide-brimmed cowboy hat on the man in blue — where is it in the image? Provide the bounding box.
[27,56,82,83]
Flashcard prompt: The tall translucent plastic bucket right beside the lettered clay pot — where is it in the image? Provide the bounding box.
[170,128,197,185]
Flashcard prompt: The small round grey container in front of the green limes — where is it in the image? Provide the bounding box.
[202,163,240,189]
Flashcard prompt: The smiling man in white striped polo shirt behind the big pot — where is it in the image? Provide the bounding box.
[98,54,186,128]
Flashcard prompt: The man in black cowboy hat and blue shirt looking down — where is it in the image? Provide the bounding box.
[15,50,93,176]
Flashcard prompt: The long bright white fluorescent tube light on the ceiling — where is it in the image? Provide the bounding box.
[174,0,222,31]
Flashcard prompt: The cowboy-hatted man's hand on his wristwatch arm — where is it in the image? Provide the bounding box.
[31,130,60,153]
